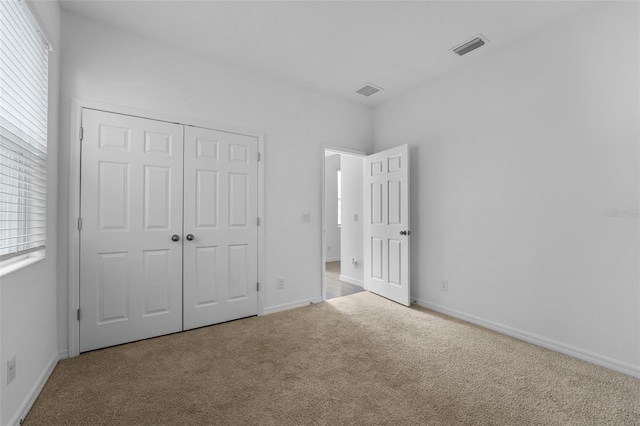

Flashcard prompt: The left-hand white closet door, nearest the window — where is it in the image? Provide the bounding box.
[80,109,183,351]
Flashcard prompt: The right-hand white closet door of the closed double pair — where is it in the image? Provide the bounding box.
[184,127,258,330]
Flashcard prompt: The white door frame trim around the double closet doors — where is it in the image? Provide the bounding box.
[68,98,264,358]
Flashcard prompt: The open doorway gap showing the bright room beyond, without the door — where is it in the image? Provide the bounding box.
[323,149,364,300]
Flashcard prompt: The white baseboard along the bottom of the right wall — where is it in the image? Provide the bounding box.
[412,298,640,378]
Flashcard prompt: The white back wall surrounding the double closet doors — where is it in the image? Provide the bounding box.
[58,12,372,349]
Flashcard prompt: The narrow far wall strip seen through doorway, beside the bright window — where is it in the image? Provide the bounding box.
[324,154,340,262]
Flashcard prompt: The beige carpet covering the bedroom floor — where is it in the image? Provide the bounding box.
[25,292,640,426]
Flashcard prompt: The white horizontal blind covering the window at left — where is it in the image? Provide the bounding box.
[0,0,49,261]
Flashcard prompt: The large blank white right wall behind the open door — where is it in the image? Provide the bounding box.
[374,2,640,375]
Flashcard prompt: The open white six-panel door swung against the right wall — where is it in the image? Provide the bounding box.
[364,145,410,306]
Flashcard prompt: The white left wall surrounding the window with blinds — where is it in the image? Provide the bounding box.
[0,2,61,425]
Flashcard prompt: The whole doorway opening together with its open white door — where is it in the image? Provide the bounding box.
[322,144,411,306]
